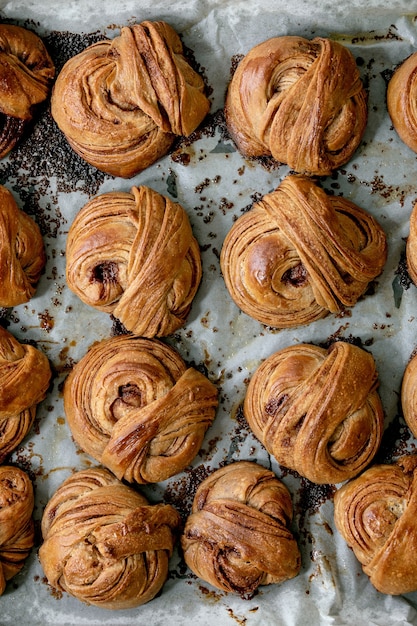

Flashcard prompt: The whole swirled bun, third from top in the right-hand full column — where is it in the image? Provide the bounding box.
[244,341,384,484]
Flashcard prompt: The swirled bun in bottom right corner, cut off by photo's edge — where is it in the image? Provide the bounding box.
[334,455,417,595]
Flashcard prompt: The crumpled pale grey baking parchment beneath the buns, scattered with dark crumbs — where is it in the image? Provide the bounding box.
[0,0,417,626]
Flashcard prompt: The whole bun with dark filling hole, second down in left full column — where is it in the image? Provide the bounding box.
[66,185,202,337]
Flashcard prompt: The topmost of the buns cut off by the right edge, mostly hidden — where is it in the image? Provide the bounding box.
[387,52,417,152]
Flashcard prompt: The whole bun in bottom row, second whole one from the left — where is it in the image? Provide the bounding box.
[181,461,301,597]
